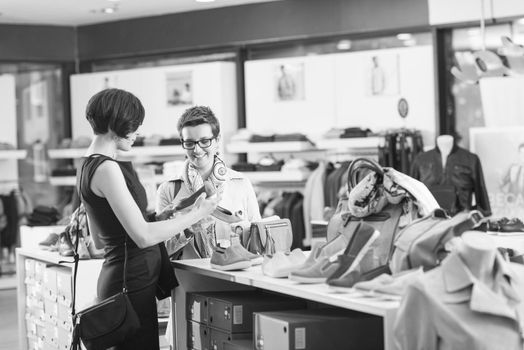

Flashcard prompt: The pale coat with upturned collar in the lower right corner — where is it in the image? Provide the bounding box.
[394,252,524,350]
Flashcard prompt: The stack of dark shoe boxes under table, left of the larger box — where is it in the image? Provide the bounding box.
[186,291,306,350]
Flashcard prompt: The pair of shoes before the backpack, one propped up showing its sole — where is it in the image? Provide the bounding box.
[289,222,380,283]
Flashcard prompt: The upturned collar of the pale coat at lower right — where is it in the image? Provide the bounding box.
[442,253,521,320]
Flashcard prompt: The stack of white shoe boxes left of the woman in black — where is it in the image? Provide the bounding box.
[24,259,72,350]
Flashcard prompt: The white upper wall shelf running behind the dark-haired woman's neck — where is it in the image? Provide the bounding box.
[47,146,186,159]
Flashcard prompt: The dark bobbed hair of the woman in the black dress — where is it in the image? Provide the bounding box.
[86,89,145,137]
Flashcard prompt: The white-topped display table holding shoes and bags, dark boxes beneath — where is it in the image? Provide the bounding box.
[172,259,399,350]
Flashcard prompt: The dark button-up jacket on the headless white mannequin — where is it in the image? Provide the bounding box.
[410,145,491,216]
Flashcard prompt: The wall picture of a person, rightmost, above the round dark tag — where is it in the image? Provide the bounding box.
[367,54,400,96]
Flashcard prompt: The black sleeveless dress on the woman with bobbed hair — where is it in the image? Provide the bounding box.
[79,155,161,350]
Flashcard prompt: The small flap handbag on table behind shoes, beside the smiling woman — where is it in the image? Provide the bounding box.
[246,219,293,255]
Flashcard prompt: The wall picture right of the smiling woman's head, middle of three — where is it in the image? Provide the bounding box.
[274,63,304,101]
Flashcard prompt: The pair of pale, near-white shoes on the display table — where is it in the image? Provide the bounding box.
[262,248,307,278]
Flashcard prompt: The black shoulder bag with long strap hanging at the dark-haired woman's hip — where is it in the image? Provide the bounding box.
[70,158,140,350]
